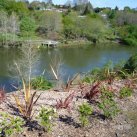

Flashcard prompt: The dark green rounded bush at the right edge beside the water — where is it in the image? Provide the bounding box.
[124,54,137,73]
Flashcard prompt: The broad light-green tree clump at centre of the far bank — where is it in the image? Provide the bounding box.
[63,12,107,43]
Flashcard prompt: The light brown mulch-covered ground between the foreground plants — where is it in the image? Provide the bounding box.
[1,80,137,137]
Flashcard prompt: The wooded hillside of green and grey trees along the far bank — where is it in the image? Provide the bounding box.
[0,0,137,45]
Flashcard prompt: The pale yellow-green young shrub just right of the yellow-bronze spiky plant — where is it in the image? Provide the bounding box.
[37,107,56,132]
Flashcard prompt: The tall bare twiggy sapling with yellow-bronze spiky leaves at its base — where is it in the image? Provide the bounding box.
[10,45,40,119]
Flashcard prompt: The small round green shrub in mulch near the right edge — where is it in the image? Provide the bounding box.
[120,87,133,98]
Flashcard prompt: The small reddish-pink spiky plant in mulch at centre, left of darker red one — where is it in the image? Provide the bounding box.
[56,92,75,110]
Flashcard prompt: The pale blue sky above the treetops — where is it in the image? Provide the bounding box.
[29,0,137,8]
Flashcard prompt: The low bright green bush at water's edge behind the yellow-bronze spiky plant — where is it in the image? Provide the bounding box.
[31,76,52,90]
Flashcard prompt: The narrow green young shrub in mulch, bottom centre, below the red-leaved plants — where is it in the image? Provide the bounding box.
[78,103,93,127]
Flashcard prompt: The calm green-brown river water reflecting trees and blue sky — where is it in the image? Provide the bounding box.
[0,44,137,92]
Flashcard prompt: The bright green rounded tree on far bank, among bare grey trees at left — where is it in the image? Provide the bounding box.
[20,17,36,38]
